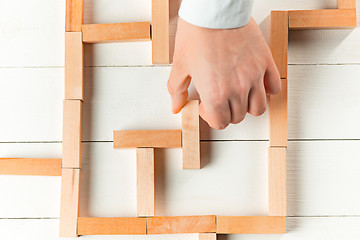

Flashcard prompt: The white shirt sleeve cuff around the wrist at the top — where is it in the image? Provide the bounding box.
[179,0,253,29]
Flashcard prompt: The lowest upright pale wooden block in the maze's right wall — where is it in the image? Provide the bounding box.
[269,147,286,216]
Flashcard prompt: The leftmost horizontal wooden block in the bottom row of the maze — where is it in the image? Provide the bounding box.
[78,217,146,235]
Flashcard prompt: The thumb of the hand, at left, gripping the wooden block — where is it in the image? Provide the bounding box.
[167,65,191,113]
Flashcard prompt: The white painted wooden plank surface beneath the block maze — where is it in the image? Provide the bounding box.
[0,0,360,240]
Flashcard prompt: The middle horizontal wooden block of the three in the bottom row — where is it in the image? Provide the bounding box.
[147,215,216,234]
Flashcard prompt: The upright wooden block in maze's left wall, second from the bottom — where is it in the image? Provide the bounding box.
[62,100,82,168]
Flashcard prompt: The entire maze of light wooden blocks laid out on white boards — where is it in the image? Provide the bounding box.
[0,0,356,240]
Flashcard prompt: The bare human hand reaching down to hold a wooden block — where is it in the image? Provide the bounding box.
[168,18,281,129]
